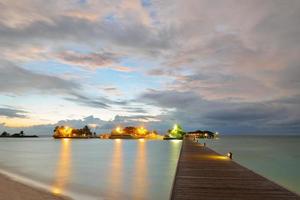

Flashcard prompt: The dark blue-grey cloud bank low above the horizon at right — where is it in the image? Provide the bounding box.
[140,90,300,134]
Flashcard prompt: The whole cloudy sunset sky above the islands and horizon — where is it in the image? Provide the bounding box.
[0,0,300,135]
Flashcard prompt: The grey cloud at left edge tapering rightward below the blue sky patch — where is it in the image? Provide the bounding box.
[0,61,126,109]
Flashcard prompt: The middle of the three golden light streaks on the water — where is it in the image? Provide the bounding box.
[109,139,123,199]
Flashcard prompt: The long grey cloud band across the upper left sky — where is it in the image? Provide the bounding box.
[0,8,170,55]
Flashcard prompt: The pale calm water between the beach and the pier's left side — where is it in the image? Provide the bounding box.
[0,138,181,199]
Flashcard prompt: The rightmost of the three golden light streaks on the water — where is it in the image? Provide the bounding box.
[132,140,148,199]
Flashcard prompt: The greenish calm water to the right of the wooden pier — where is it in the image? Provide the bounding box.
[200,136,300,194]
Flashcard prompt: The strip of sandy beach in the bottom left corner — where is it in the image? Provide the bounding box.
[0,174,69,200]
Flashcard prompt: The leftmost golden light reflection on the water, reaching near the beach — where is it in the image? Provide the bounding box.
[52,139,71,194]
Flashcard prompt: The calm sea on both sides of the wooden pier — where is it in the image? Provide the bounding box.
[0,136,300,200]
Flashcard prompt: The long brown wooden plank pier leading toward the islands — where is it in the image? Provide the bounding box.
[170,139,300,200]
